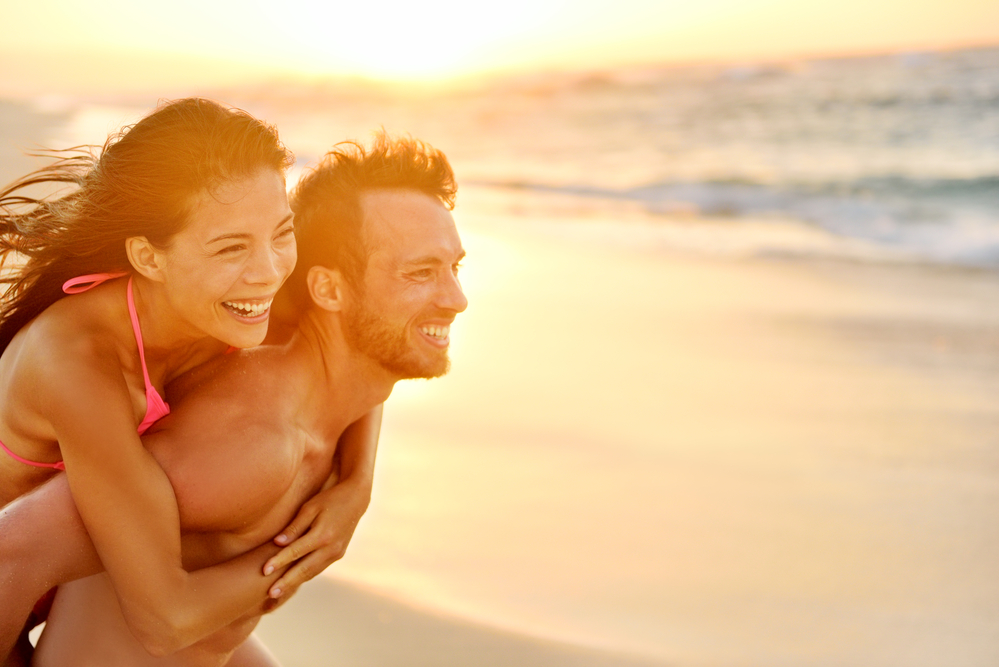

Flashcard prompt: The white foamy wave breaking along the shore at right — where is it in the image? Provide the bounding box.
[477,175,999,268]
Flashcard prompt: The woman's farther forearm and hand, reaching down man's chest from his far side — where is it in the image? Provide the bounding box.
[264,405,383,598]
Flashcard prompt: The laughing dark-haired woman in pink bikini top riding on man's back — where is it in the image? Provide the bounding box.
[0,99,380,653]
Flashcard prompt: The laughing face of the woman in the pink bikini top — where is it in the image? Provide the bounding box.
[153,169,297,348]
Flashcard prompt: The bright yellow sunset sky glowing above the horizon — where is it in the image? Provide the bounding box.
[0,0,999,94]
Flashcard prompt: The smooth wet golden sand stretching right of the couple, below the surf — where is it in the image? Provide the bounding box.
[252,188,999,666]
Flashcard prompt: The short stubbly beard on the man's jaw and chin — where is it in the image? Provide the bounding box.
[344,297,451,380]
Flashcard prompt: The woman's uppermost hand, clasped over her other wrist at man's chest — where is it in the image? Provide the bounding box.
[264,479,371,598]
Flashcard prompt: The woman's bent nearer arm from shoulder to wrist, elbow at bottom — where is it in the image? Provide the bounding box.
[37,345,277,655]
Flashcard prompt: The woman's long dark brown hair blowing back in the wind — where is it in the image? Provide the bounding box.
[0,98,293,353]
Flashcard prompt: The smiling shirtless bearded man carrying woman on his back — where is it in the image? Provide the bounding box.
[0,137,467,667]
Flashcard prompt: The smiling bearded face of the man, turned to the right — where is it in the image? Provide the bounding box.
[345,190,468,379]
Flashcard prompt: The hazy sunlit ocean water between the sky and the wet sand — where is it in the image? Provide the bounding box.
[7,44,999,267]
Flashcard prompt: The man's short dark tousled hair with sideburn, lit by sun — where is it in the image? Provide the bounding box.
[286,133,458,312]
